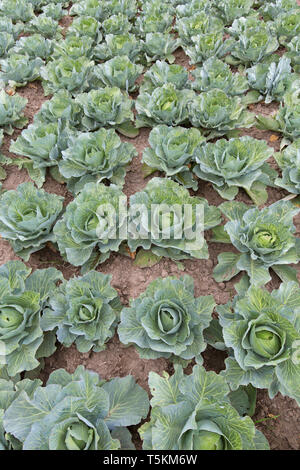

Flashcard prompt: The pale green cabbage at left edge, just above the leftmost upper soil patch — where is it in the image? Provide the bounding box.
[0,53,44,86]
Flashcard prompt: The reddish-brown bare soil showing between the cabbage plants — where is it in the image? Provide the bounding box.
[0,7,300,450]
